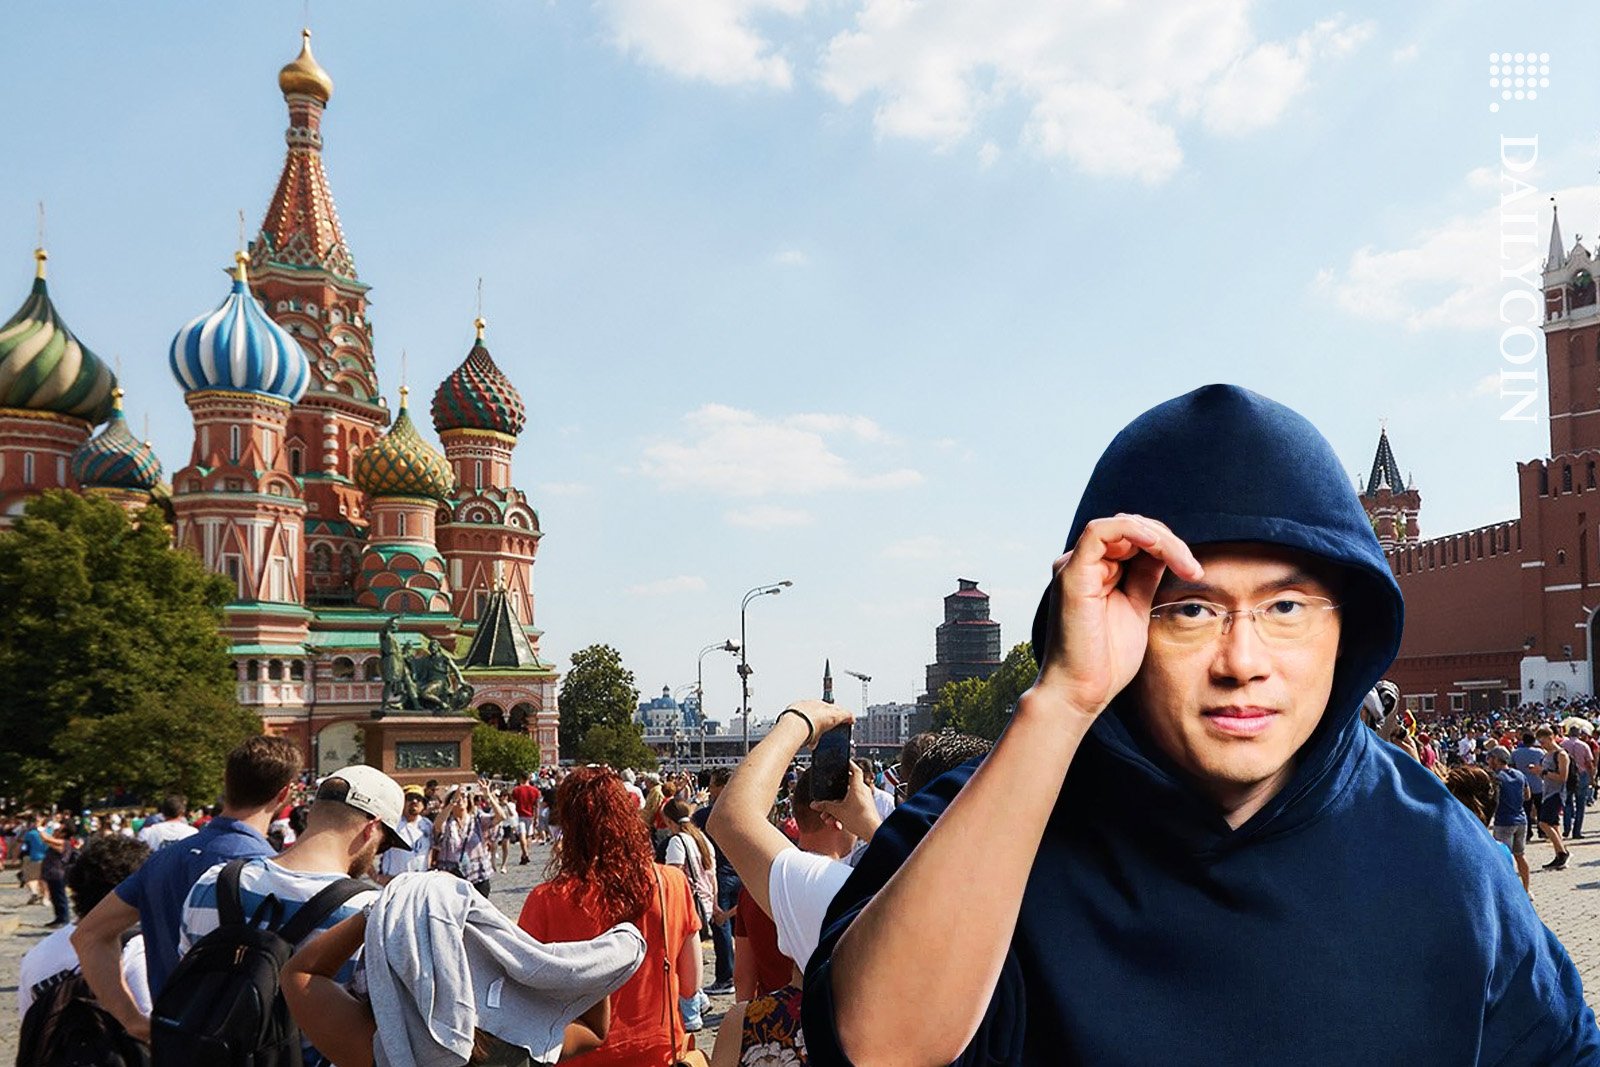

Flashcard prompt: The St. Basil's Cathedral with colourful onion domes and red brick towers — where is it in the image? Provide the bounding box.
[0,30,558,773]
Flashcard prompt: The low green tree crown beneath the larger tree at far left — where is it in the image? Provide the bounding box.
[50,688,261,806]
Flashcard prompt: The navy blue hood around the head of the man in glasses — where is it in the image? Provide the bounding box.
[1034,386,1405,848]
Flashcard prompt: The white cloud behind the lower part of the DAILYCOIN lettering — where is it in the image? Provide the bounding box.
[1314,179,1600,331]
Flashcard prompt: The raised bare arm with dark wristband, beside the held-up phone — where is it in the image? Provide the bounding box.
[706,701,856,912]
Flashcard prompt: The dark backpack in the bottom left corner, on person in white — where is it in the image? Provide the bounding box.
[16,933,150,1067]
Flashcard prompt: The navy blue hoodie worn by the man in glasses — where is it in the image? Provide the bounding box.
[803,386,1600,1067]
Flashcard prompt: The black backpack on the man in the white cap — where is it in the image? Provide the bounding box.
[150,859,370,1067]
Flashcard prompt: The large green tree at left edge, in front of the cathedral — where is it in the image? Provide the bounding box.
[0,491,234,795]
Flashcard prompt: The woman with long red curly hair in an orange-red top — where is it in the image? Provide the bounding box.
[517,766,701,1067]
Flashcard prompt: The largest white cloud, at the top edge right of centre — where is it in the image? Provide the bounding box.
[819,0,1371,182]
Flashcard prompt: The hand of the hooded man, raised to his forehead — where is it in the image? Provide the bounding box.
[1030,515,1203,717]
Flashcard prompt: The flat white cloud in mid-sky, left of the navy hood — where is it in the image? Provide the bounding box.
[638,405,922,499]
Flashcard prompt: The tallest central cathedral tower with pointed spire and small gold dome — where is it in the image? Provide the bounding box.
[250,30,389,603]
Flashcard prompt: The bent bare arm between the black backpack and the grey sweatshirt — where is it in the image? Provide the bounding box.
[278,912,378,1067]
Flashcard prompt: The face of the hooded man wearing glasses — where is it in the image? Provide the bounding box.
[1133,544,1341,805]
